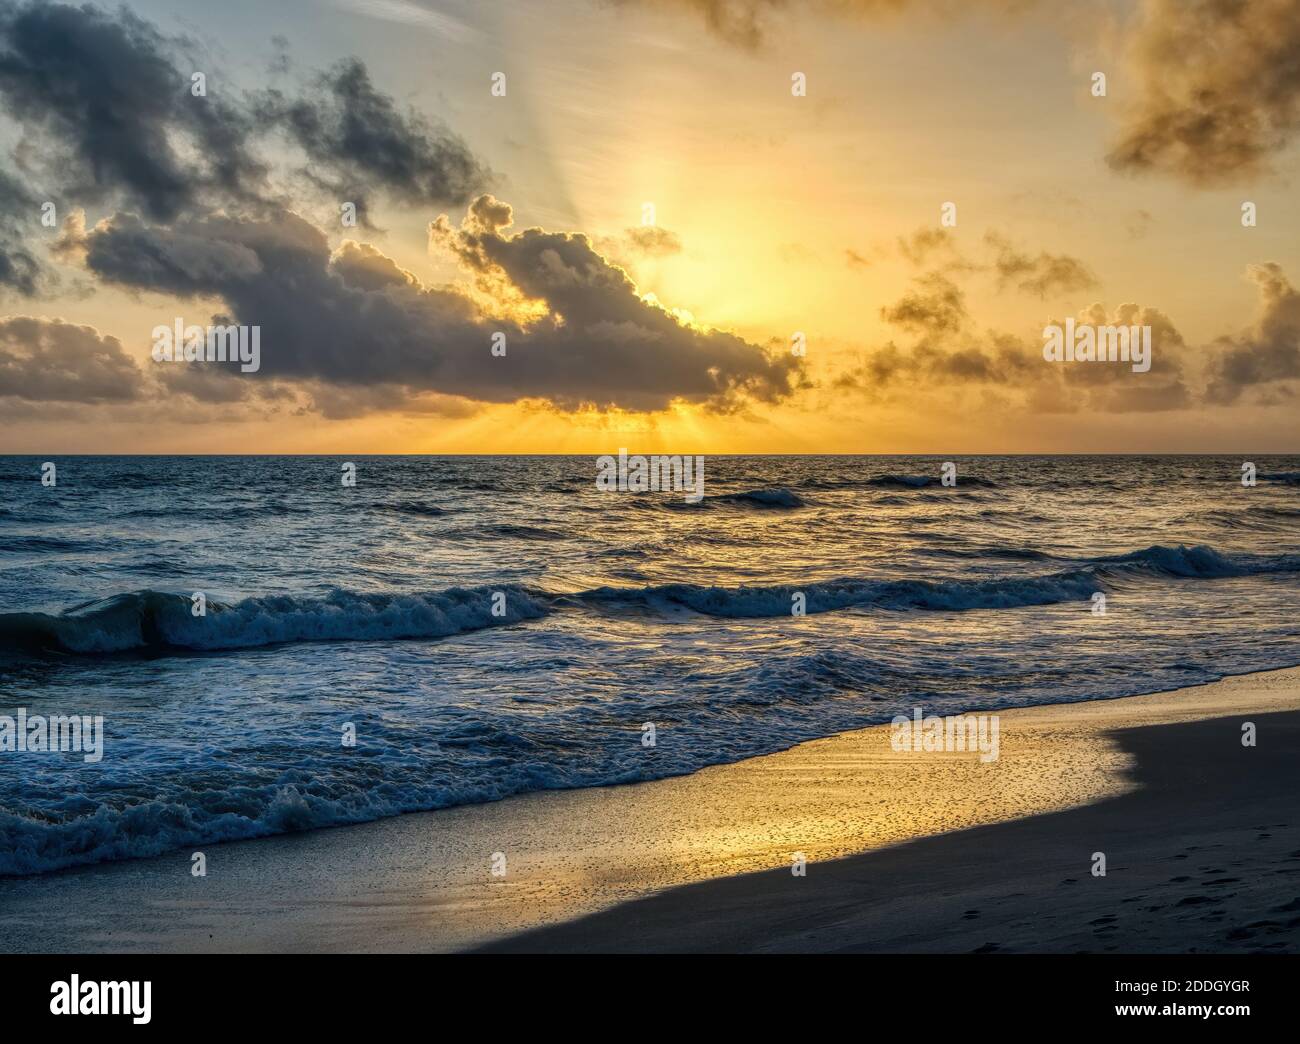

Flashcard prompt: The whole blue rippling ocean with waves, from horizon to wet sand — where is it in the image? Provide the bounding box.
[0,456,1300,875]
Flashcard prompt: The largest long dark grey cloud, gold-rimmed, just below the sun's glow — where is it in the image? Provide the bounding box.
[76,198,797,411]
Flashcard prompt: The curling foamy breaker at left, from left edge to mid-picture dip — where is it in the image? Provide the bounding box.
[0,585,547,654]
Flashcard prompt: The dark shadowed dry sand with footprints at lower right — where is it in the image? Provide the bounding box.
[477,711,1300,954]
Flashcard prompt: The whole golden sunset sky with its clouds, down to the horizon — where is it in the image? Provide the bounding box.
[0,0,1300,454]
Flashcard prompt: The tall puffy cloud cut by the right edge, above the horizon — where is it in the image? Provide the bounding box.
[1205,261,1300,406]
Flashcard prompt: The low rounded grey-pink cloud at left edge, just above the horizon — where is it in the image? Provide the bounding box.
[0,316,144,403]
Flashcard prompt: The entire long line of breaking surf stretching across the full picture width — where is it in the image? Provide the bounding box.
[0,545,1300,654]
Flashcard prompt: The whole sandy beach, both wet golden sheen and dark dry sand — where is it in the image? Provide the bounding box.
[0,668,1300,953]
